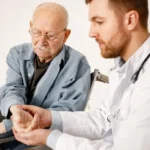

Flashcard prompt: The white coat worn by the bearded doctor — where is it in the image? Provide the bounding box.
[47,38,150,150]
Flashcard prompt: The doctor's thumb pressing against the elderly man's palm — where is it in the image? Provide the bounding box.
[25,114,40,132]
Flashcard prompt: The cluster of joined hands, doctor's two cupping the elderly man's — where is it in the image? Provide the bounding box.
[10,105,52,146]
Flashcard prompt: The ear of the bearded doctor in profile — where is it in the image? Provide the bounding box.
[125,10,139,30]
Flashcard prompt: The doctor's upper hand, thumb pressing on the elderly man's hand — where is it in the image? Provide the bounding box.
[13,105,52,131]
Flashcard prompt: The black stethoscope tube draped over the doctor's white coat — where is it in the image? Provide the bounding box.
[131,54,150,84]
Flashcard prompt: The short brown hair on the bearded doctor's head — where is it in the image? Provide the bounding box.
[85,0,148,28]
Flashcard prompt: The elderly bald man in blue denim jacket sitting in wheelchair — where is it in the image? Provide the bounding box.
[0,2,90,133]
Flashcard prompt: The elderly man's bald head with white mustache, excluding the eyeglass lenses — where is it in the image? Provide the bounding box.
[30,2,70,62]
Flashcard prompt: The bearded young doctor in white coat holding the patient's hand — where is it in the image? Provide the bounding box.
[11,0,150,150]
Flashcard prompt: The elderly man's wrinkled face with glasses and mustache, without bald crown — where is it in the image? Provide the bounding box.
[29,9,70,62]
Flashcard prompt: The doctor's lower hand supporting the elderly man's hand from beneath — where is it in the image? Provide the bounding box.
[13,129,51,146]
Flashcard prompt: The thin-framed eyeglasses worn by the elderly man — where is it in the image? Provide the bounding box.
[29,29,66,41]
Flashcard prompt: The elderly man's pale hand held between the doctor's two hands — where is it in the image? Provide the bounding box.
[10,105,34,132]
